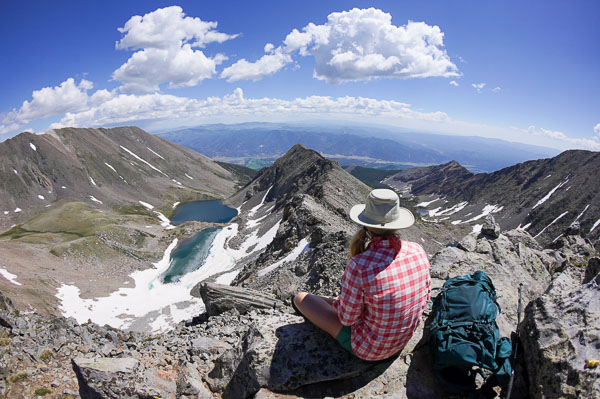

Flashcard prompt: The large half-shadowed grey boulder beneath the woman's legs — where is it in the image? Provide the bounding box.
[208,313,373,398]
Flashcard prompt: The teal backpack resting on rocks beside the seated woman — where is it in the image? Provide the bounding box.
[428,270,512,393]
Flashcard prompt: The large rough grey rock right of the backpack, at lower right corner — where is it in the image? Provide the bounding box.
[521,273,600,398]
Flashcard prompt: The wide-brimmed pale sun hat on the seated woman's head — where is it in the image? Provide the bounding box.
[350,188,415,230]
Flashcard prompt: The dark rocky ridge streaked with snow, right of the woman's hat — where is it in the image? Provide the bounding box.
[383,150,600,245]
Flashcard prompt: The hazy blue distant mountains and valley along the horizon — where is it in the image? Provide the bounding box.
[159,123,559,172]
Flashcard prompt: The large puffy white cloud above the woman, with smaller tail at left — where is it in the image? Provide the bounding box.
[221,8,460,83]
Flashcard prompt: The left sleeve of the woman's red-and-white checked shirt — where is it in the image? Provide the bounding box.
[334,260,363,326]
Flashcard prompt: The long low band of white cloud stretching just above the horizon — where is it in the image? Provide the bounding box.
[50,88,448,128]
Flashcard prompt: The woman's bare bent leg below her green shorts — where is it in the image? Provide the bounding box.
[294,292,343,338]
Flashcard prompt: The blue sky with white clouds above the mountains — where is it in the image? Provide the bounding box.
[0,0,600,151]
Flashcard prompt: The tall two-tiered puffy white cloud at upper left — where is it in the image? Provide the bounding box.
[112,6,237,93]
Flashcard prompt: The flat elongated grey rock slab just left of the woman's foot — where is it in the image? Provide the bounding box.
[190,283,283,316]
